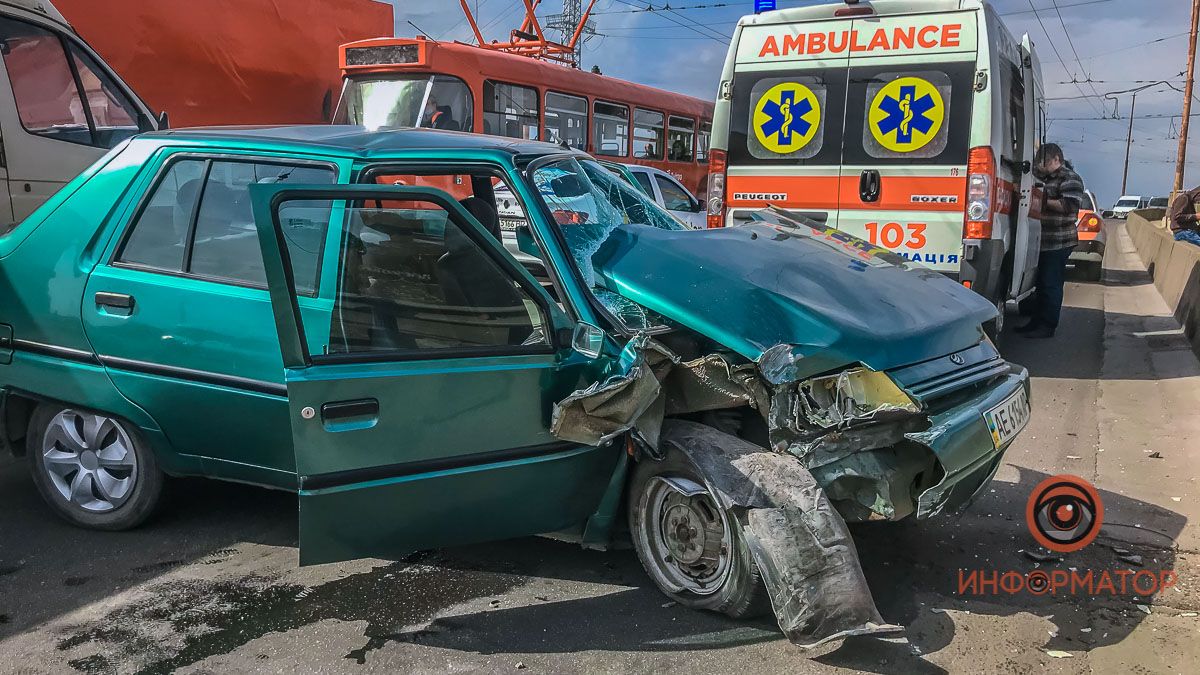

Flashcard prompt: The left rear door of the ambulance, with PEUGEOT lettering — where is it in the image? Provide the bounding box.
[726,19,853,227]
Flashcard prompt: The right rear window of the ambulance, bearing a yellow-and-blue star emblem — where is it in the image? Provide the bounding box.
[863,71,952,159]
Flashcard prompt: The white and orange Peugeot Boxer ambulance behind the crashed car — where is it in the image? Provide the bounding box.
[707,0,1045,334]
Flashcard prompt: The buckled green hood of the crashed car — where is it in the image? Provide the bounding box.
[592,222,996,383]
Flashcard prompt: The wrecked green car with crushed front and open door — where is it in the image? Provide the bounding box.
[0,126,1028,643]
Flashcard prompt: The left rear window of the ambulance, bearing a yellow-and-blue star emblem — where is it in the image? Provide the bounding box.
[746,76,828,160]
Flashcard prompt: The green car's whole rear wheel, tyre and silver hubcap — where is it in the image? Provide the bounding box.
[26,404,163,530]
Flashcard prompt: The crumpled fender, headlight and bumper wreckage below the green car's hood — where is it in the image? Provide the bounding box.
[551,335,1028,646]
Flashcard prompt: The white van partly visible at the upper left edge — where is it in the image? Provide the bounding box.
[0,0,166,227]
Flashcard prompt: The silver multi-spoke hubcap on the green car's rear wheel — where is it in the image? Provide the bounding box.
[42,410,138,513]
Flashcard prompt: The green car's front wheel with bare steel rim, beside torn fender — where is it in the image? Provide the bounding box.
[629,450,770,619]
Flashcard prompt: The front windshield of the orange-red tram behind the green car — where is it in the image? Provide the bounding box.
[334,74,475,131]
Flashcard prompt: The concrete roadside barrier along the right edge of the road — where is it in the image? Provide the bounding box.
[1126,209,1200,356]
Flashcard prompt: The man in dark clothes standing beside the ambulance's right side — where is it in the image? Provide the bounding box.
[1016,143,1084,338]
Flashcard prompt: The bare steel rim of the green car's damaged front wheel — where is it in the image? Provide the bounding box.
[637,478,732,596]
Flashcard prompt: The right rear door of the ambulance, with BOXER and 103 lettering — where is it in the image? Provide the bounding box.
[838,11,978,276]
